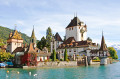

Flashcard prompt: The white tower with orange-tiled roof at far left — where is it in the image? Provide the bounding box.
[7,30,23,53]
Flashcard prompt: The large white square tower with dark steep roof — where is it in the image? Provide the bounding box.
[66,16,87,41]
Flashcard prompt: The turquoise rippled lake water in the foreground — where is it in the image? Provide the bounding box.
[0,62,120,79]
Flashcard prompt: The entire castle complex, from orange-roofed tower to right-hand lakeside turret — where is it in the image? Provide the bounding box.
[7,16,109,66]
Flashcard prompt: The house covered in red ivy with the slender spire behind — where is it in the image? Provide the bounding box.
[13,28,51,66]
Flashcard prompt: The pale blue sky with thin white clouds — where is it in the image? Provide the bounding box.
[0,0,120,46]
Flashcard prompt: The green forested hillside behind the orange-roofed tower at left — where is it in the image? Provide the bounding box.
[0,26,30,43]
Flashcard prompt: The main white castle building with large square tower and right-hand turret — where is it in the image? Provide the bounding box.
[51,16,109,60]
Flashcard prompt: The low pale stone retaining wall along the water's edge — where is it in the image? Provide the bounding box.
[37,61,77,67]
